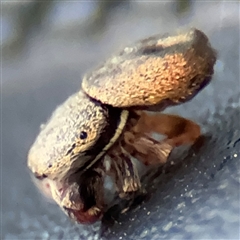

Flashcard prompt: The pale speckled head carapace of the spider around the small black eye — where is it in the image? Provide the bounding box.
[28,91,122,179]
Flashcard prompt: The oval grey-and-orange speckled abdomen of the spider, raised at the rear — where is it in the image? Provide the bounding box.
[82,29,216,108]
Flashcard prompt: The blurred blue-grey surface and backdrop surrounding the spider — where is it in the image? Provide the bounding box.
[1,0,240,239]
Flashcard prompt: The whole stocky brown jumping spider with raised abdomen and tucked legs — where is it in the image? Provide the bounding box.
[28,29,216,223]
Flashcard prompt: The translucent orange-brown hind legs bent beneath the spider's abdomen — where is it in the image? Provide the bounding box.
[124,112,200,165]
